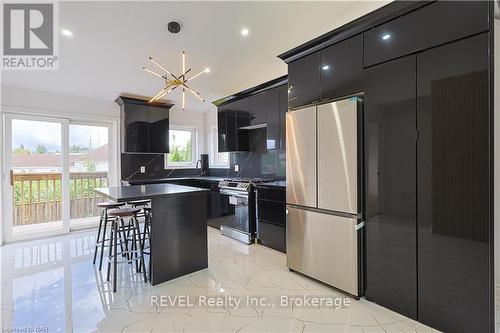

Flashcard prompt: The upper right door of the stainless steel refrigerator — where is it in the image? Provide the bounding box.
[318,97,358,214]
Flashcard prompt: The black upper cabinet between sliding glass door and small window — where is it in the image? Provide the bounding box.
[115,96,173,154]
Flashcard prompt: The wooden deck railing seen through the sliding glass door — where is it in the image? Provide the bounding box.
[13,172,108,226]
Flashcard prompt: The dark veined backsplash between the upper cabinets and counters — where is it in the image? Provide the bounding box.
[121,128,286,180]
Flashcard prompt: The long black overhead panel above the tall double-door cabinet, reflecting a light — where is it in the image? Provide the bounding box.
[364,1,489,66]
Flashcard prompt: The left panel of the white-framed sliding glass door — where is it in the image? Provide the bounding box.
[3,115,70,241]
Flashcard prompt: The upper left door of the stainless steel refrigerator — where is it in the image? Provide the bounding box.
[286,106,317,207]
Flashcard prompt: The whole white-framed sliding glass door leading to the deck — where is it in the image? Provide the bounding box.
[3,114,114,241]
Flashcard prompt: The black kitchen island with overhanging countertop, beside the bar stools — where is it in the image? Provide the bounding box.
[95,184,210,285]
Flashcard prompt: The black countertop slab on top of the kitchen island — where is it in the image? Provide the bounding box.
[95,184,210,201]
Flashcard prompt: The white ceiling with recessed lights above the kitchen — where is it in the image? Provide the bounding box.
[2,1,388,112]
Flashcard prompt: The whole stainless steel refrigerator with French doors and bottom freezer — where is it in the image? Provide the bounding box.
[286,97,364,296]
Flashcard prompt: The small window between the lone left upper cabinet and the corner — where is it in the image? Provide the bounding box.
[166,126,197,167]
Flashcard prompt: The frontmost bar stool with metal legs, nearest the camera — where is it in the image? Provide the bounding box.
[106,207,147,292]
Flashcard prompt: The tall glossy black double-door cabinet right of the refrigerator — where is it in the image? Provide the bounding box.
[365,33,493,332]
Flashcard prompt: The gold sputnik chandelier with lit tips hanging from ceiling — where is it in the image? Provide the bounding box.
[142,22,210,110]
